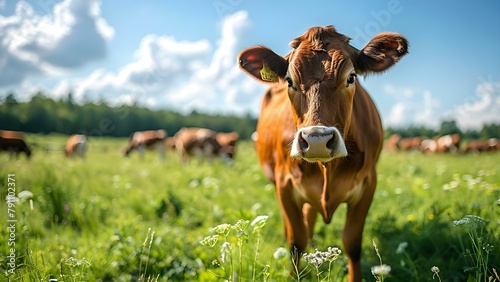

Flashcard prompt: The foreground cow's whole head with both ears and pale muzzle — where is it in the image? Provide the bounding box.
[239,26,408,162]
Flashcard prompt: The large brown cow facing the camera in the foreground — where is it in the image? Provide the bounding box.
[238,26,408,281]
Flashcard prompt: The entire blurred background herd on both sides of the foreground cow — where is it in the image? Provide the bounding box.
[0,128,500,162]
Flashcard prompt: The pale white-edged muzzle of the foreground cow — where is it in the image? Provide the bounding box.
[290,126,347,162]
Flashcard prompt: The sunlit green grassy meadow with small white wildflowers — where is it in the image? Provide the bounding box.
[0,135,500,281]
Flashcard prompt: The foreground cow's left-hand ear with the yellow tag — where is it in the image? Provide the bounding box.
[238,46,288,83]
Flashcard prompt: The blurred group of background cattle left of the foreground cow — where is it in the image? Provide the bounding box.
[0,128,239,162]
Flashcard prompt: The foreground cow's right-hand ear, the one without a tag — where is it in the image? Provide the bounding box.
[356,32,408,74]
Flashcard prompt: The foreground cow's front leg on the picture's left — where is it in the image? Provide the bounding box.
[276,181,308,270]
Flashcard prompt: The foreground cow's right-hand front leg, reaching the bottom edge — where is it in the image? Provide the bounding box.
[342,177,377,282]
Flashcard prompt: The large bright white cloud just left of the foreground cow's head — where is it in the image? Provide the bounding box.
[54,11,263,114]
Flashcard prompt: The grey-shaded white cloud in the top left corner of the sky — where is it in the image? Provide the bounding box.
[0,0,114,87]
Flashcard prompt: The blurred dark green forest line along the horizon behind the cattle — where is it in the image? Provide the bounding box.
[0,92,500,139]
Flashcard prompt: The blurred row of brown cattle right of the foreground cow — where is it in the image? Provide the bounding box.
[386,133,500,154]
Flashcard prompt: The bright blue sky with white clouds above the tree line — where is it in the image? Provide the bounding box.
[0,0,500,129]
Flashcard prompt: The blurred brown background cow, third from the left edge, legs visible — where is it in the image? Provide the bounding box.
[125,129,167,161]
